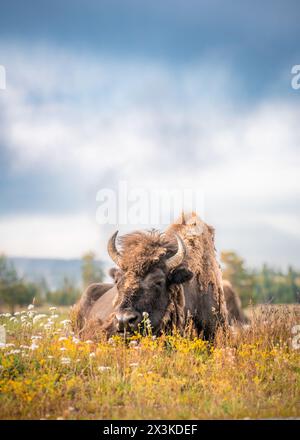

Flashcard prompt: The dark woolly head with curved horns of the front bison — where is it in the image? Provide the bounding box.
[108,231,193,333]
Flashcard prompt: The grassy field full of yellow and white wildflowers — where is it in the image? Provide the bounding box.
[0,306,300,419]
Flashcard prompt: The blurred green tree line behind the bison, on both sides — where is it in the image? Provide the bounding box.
[0,251,300,312]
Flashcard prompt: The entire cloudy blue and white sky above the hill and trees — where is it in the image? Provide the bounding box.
[0,0,300,268]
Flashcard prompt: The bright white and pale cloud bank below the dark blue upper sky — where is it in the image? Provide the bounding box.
[0,46,300,264]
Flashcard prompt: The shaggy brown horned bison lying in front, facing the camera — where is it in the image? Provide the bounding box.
[75,214,228,339]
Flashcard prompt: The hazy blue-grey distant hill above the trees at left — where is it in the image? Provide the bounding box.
[9,257,107,290]
